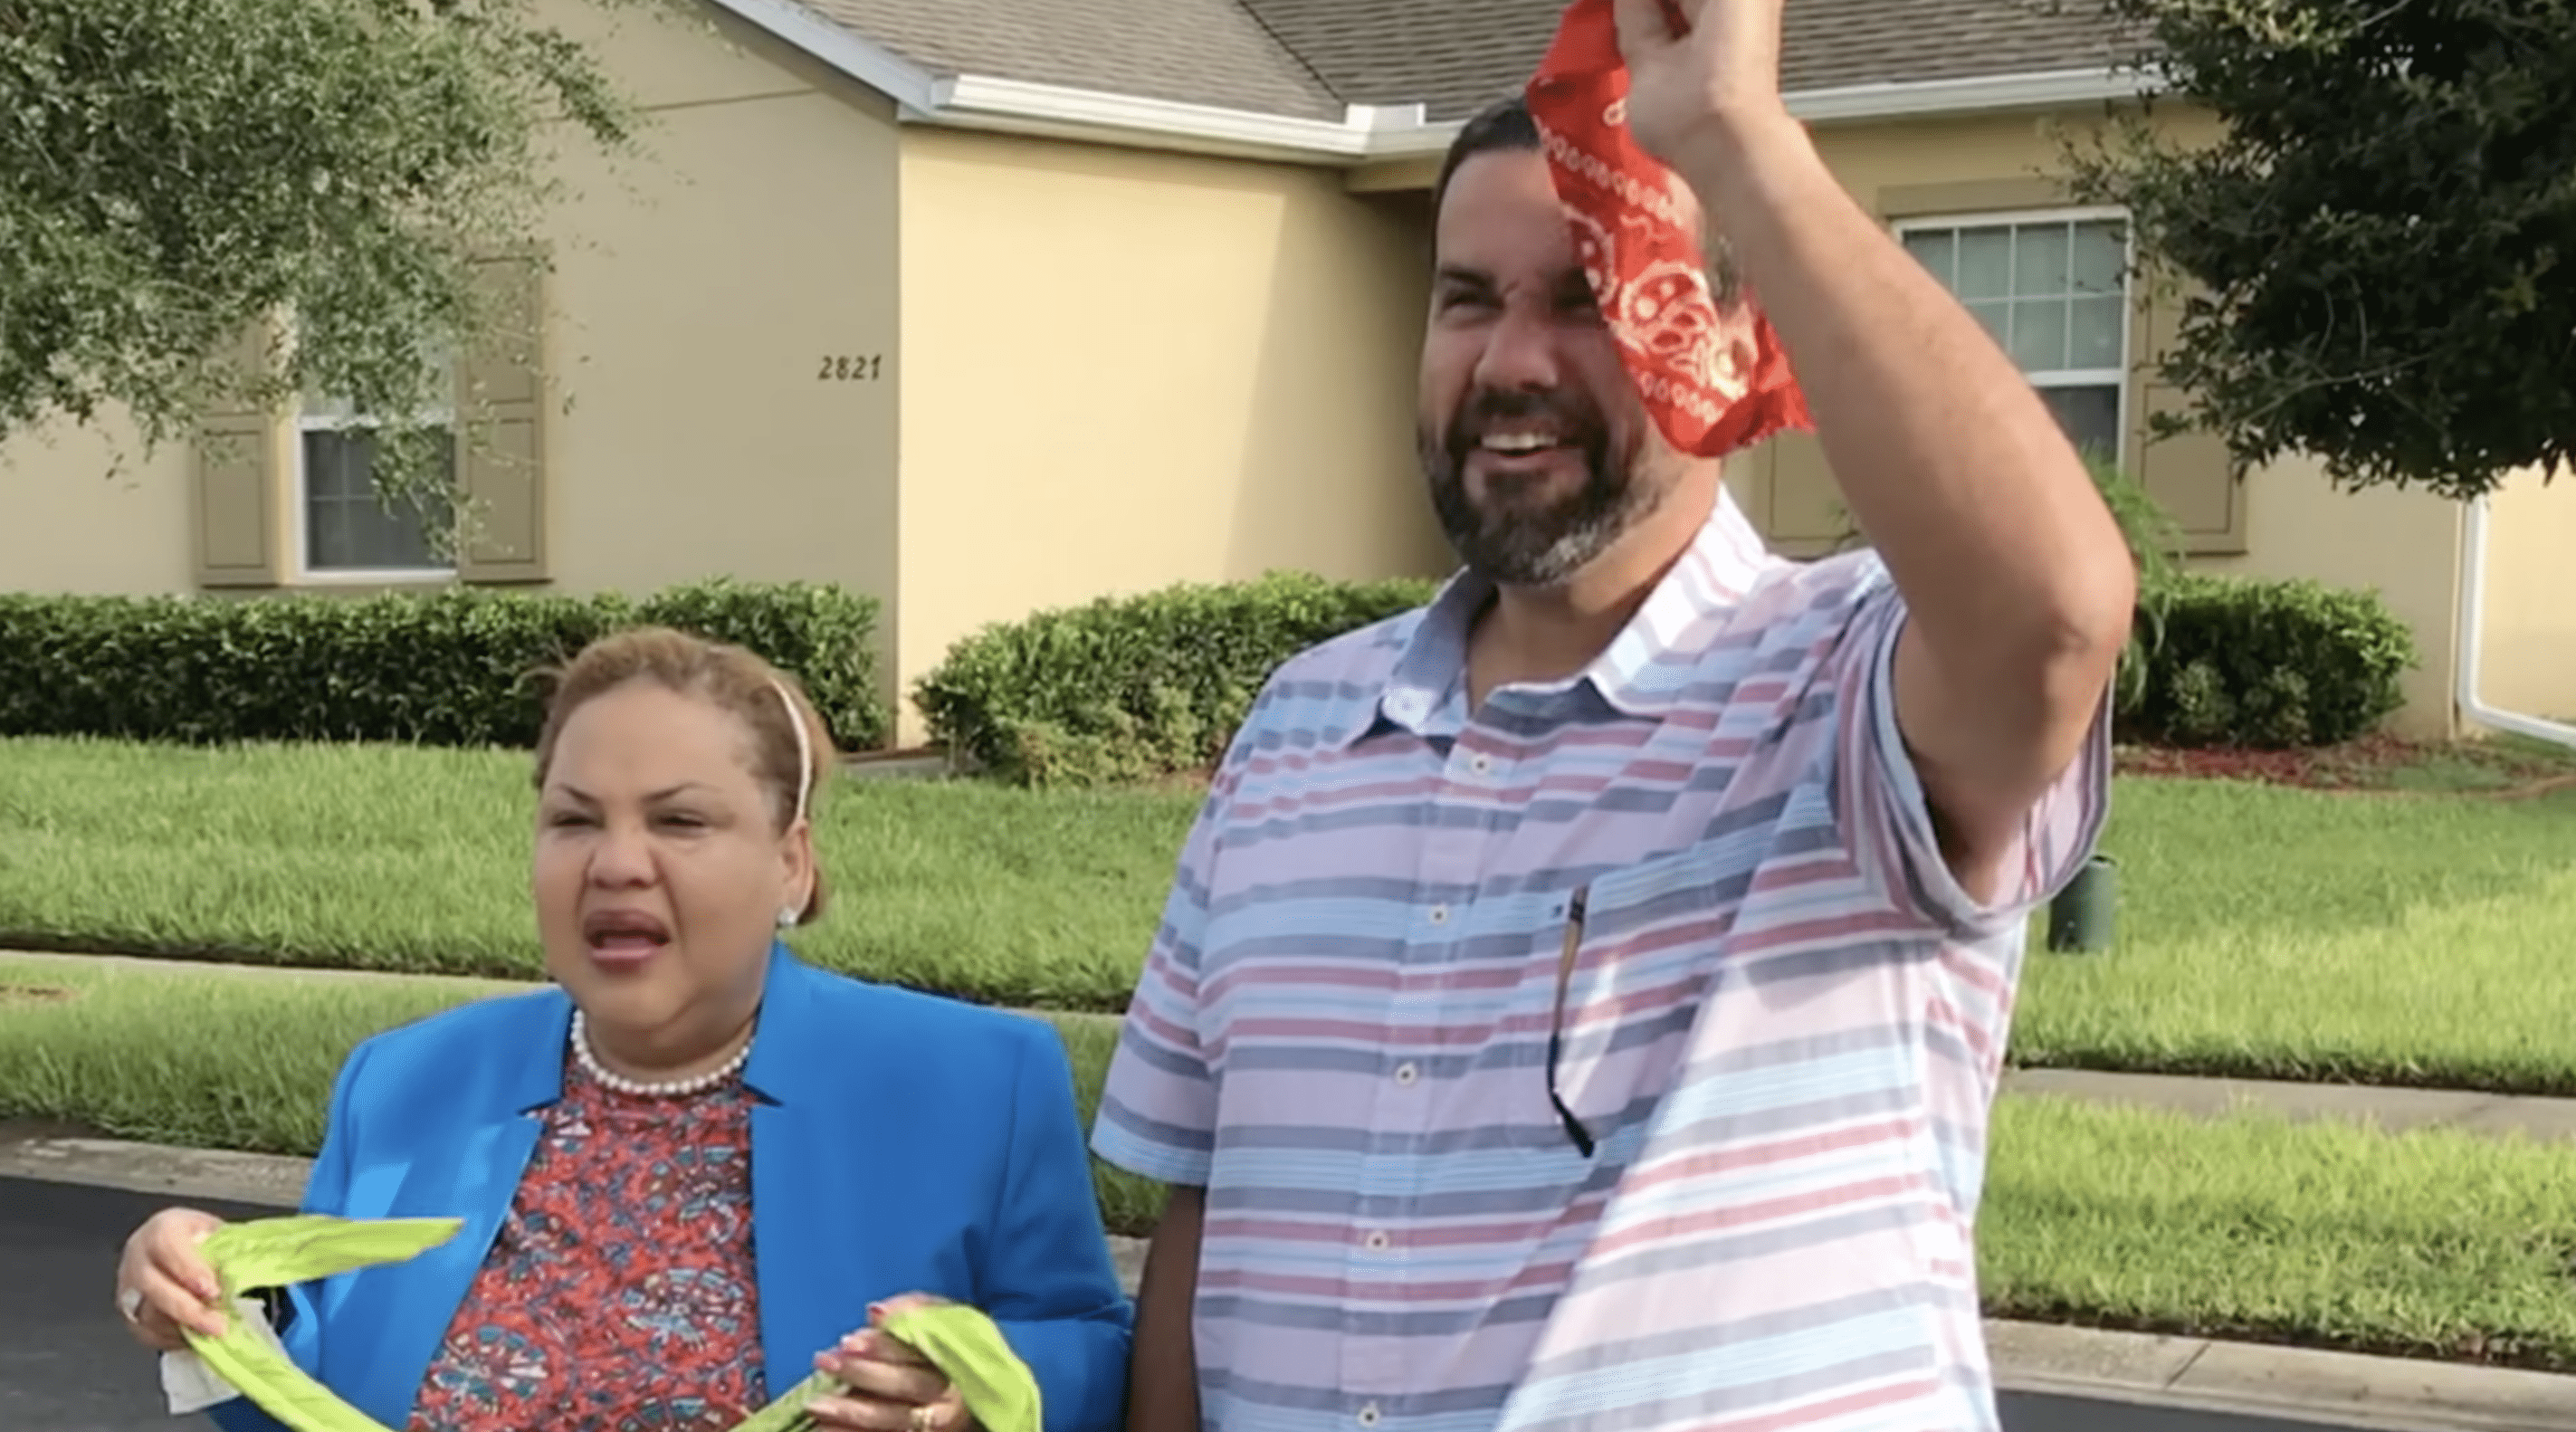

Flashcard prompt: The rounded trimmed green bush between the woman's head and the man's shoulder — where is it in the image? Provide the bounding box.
[914,572,1437,786]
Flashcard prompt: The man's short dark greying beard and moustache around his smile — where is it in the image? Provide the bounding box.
[1417,391,1654,587]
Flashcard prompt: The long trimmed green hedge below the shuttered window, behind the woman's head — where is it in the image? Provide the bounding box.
[0,577,889,749]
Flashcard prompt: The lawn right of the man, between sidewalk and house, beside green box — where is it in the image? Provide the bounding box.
[2012,780,2576,1094]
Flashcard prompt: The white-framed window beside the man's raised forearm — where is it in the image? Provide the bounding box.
[1899,214,2128,458]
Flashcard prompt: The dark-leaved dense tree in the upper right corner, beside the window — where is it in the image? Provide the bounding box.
[2068,0,2576,497]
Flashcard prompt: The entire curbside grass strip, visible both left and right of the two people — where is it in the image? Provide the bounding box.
[0,958,2576,1370]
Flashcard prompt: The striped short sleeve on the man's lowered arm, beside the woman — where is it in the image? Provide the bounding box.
[1092,778,1231,1188]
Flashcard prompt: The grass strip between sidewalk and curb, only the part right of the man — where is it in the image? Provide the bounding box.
[1979,1097,2576,1370]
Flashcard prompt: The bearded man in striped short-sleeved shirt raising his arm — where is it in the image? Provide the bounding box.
[1095,0,2135,1432]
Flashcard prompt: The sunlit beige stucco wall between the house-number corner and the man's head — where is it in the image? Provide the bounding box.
[899,129,1447,721]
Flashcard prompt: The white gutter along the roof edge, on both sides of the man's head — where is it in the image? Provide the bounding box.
[713,0,2161,165]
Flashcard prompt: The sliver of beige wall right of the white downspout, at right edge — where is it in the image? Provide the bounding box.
[2478,472,2576,726]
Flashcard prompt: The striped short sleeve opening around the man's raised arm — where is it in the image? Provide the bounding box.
[1832,579,2110,938]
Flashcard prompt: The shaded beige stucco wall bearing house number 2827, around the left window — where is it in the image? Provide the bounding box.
[0,3,899,716]
